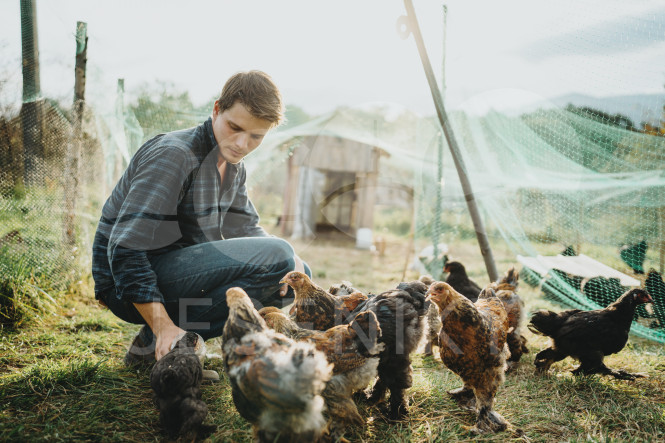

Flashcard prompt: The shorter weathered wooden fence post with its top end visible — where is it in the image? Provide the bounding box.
[63,22,88,245]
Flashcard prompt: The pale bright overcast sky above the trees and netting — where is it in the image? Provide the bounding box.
[0,0,665,115]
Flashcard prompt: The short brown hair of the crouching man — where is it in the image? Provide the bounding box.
[218,70,284,126]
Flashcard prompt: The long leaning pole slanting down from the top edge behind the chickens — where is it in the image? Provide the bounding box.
[404,0,498,281]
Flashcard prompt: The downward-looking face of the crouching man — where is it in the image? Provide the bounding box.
[212,102,272,164]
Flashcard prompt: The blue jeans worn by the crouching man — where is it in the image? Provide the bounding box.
[106,237,311,341]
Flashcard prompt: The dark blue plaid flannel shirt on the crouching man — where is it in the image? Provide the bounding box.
[92,118,268,303]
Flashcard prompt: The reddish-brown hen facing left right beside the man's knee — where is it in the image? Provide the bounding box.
[280,271,367,331]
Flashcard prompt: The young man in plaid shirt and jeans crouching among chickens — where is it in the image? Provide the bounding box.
[92,71,311,365]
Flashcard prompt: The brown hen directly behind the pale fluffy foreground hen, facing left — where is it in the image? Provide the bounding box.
[259,308,383,439]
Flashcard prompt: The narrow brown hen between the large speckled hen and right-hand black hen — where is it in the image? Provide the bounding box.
[492,267,529,370]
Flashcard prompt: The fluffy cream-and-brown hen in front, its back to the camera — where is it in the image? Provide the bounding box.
[222,288,332,442]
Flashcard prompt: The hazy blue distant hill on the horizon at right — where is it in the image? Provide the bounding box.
[549,93,665,126]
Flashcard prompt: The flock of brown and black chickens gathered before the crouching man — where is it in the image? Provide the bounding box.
[151,262,652,442]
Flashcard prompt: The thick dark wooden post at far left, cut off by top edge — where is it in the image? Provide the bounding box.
[20,0,44,186]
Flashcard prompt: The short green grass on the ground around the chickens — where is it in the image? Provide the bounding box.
[0,231,665,442]
